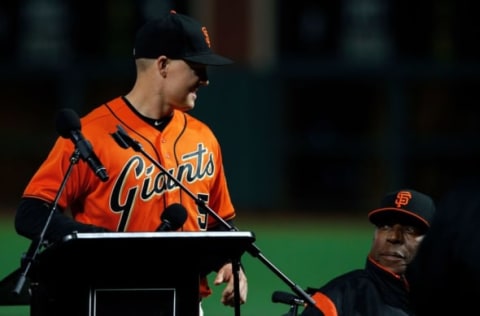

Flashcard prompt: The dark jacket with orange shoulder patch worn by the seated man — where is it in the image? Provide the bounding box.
[300,258,413,316]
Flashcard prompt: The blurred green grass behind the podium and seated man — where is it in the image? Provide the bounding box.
[0,212,373,316]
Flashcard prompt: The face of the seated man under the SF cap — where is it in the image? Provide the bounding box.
[370,220,425,275]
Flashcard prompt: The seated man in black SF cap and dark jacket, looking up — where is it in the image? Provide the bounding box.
[301,189,435,316]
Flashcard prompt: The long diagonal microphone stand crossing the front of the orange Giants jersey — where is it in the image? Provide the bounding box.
[111,125,316,315]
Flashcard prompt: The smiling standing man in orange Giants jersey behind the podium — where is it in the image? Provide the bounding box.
[15,11,247,314]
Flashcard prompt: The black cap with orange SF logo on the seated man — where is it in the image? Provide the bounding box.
[368,189,435,230]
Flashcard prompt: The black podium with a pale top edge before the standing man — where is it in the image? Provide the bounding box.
[30,231,255,316]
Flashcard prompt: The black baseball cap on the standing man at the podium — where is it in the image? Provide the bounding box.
[133,10,233,66]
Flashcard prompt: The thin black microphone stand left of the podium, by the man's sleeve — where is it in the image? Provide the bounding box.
[13,148,80,295]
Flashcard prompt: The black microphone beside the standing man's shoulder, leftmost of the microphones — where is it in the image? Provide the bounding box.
[55,109,108,182]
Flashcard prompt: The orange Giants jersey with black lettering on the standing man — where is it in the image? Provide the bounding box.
[23,97,235,296]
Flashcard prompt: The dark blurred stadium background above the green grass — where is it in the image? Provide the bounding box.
[0,0,480,214]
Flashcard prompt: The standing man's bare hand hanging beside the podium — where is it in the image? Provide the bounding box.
[213,263,248,306]
